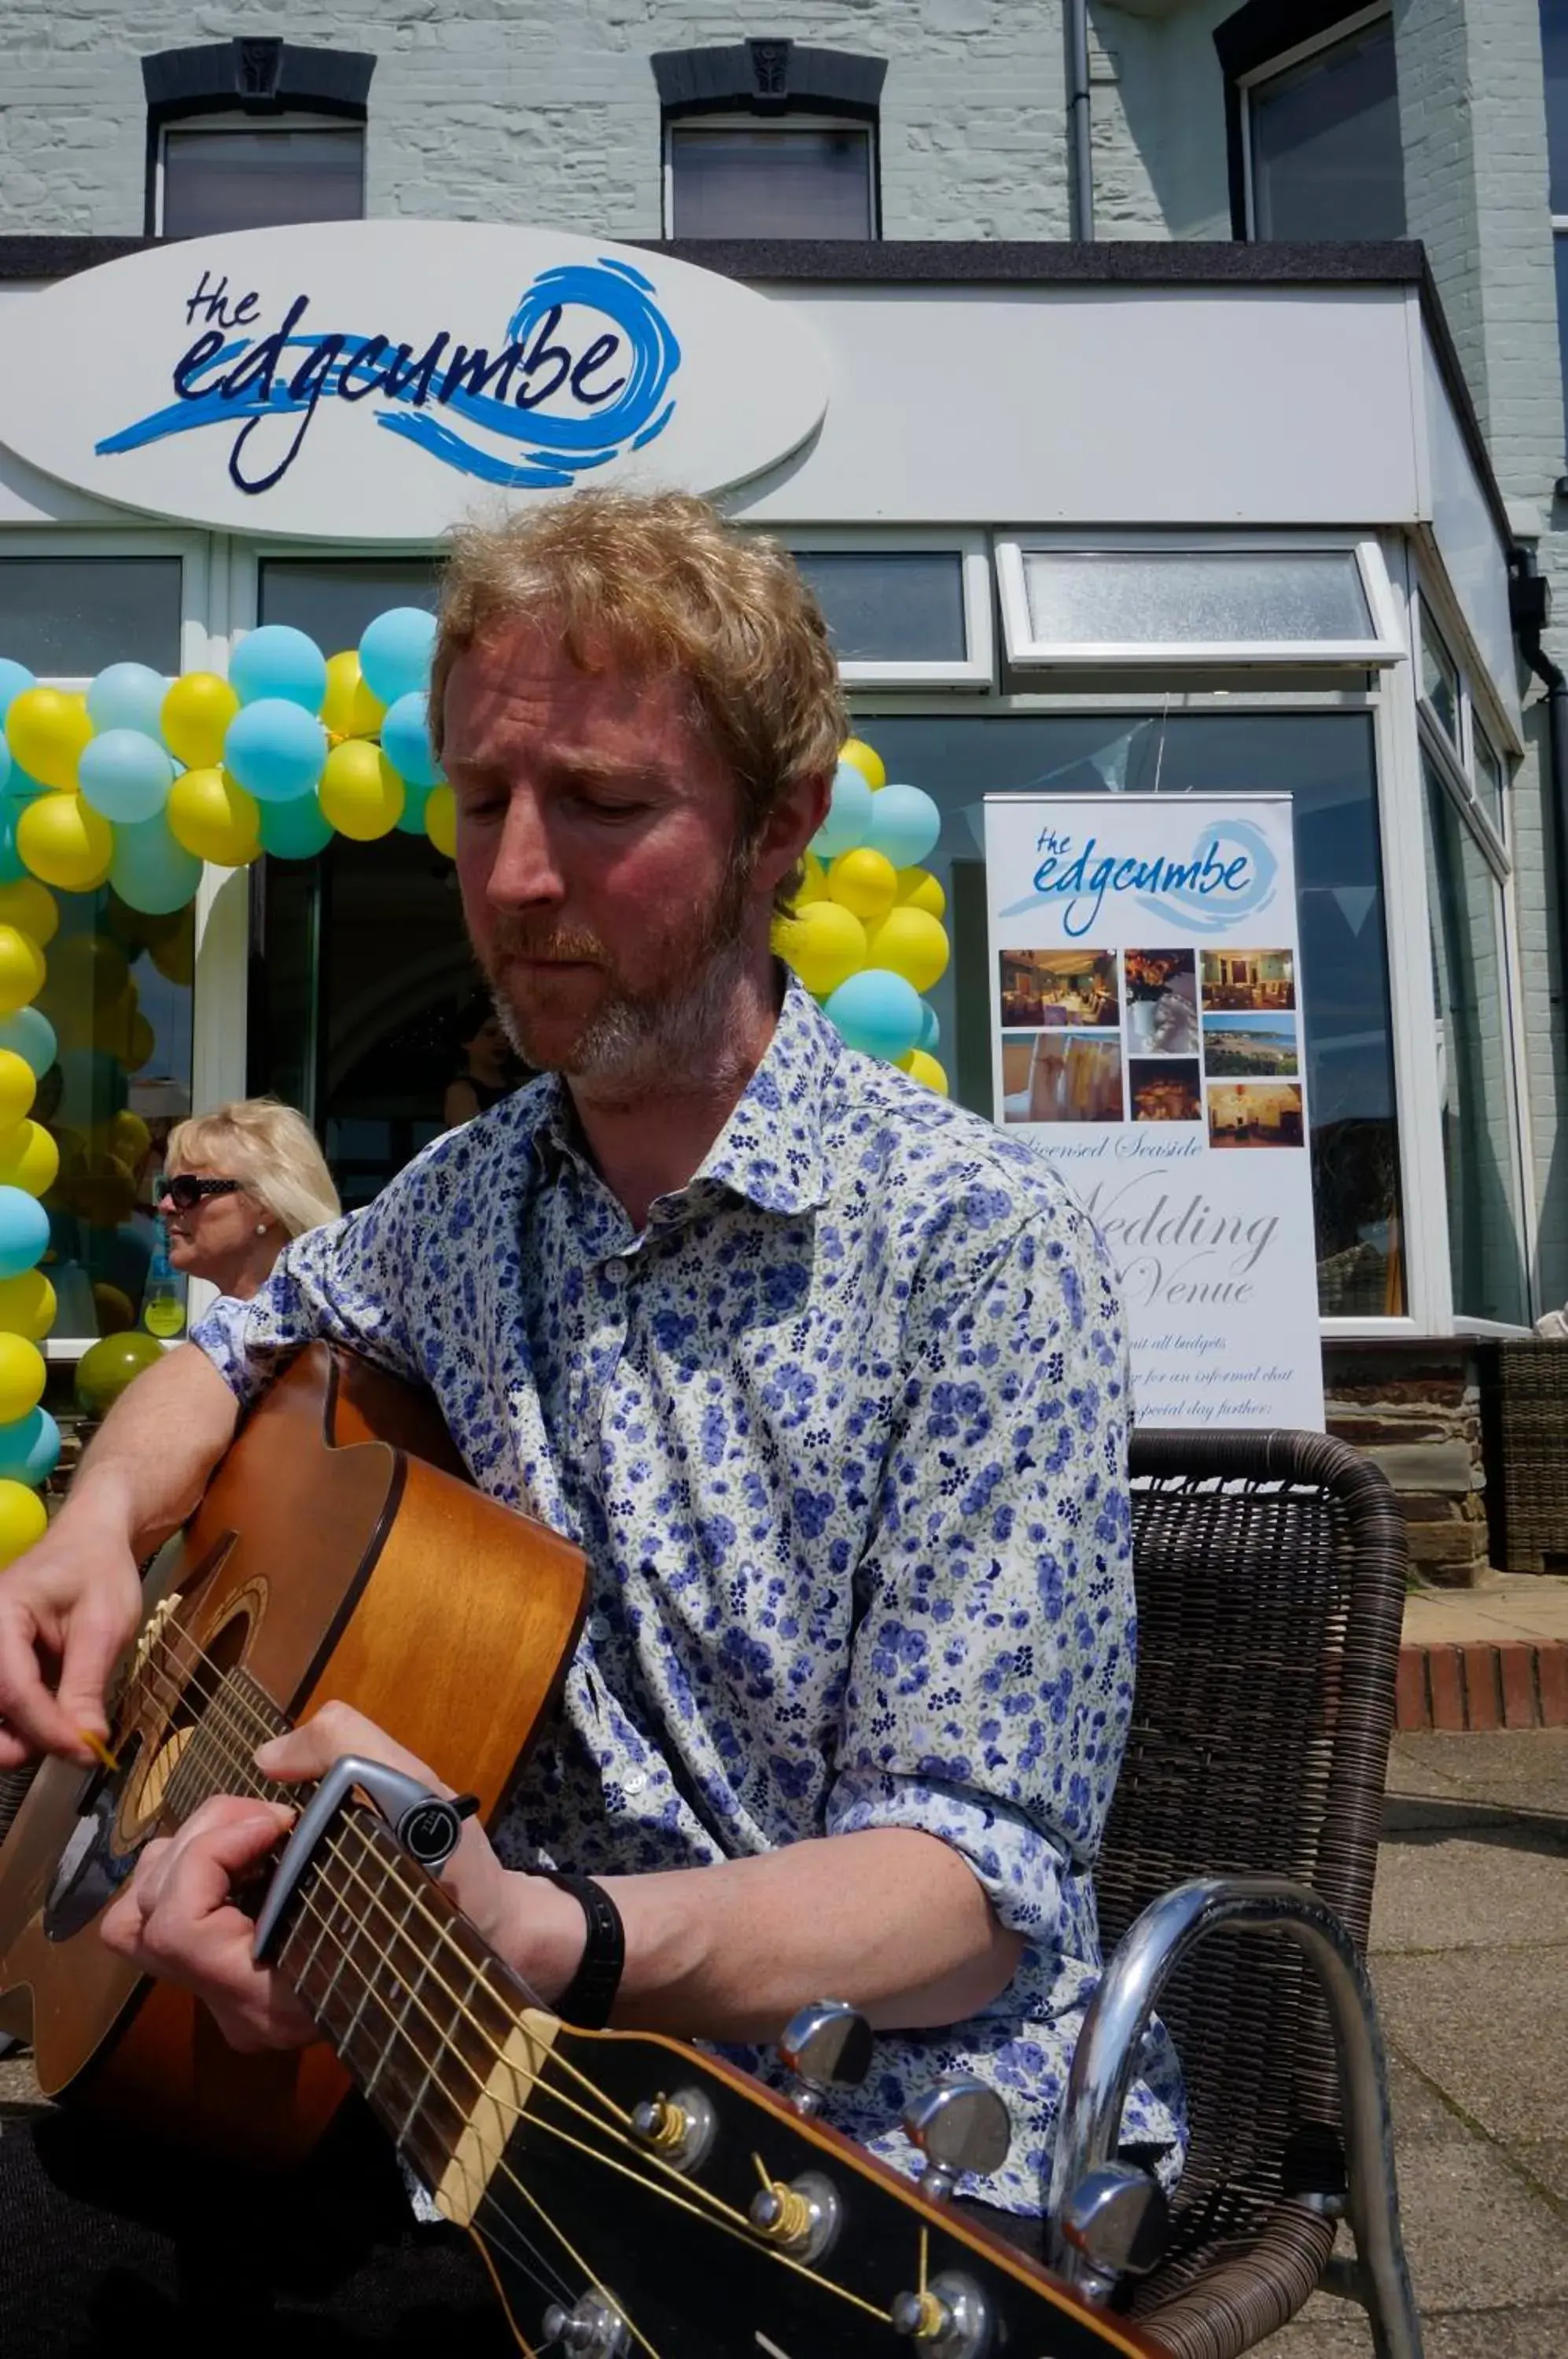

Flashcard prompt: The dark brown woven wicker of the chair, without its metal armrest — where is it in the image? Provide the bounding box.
[1096,1432,1405,2359]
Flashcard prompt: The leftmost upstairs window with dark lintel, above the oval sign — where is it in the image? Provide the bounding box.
[142,40,375,238]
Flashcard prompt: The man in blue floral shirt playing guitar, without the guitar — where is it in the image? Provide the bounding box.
[0,493,1181,2352]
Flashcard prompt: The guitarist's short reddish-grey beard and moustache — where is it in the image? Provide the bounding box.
[486,856,750,1102]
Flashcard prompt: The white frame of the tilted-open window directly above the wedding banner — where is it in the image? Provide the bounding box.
[995,531,1405,672]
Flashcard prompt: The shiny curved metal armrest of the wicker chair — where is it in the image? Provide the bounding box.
[1049,1875,1422,2359]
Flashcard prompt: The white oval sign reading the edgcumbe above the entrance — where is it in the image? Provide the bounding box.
[0,222,827,540]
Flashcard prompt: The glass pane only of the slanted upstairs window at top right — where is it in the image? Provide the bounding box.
[1247,21,1405,238]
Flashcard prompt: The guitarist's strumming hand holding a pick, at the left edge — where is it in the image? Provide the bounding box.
[0,1507,142,1769]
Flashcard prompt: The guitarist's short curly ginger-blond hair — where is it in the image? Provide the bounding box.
[429,491,848,908]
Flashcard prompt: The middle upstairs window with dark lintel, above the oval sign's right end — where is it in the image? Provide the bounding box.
[653,40,886,238]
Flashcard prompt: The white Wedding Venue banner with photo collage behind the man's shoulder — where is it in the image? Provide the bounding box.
[985,795,1323,1427]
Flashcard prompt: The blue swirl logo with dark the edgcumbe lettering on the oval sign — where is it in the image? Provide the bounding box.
[97,255,682,498]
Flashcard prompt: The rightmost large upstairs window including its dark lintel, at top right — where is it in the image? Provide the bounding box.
[1214,0,1405,241]
